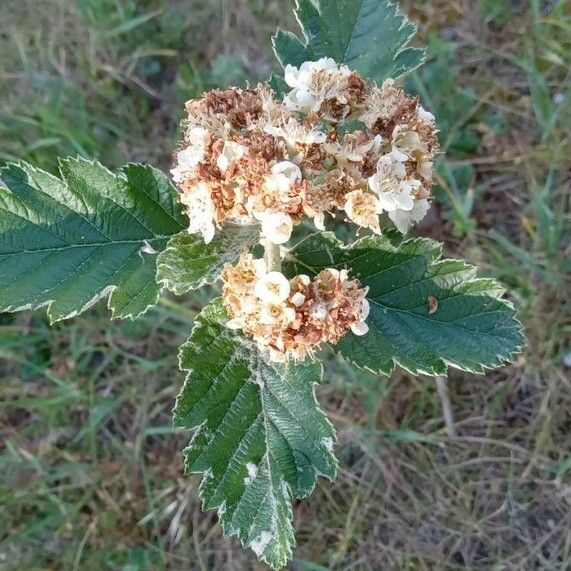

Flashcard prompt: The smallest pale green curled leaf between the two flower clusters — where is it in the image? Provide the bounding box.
[157,225,260,295]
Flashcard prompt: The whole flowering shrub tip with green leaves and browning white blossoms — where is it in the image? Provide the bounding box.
[0,0,524,568]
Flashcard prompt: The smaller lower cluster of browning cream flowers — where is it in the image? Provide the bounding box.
[222,254,369,362]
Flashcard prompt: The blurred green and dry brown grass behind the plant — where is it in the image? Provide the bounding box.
[0,0,571,571]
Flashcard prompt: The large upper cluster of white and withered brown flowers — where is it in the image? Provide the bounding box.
[172,58,438,244]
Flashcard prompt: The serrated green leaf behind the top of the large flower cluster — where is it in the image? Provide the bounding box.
[273,0,425,83]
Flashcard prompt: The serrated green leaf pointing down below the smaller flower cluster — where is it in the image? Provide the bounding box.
[174,299,337,568]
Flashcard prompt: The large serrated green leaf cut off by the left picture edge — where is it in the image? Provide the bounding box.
[0,158,186,323]
